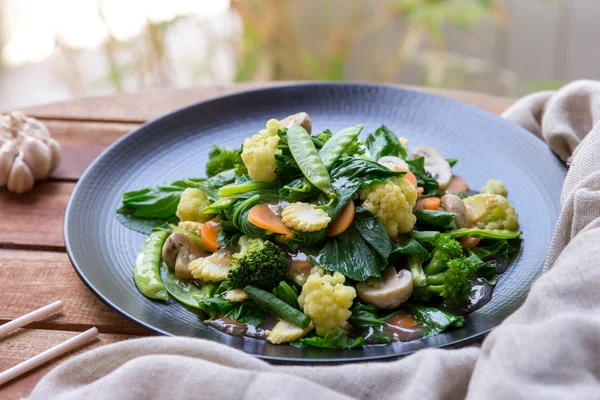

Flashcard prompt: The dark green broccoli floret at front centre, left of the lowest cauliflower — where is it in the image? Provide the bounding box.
[227,236,289,290]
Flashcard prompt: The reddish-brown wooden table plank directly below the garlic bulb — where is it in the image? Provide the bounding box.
[0,182,75,250]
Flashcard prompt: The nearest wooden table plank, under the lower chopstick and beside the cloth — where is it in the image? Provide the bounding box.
[0,329,136,400]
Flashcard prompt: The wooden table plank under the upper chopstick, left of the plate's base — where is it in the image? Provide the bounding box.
[0,250,150,335]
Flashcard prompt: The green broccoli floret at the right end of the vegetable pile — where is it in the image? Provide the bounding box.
[413,256,474,304]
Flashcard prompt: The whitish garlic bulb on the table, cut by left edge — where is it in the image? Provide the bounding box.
[0,111,60,193]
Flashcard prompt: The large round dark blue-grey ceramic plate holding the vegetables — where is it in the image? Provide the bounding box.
[65,84,565,362]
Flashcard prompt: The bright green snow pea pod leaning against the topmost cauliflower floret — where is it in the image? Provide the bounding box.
[287,125,332,195]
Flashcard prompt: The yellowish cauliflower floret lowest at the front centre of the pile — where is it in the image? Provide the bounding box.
[298,268,356,336]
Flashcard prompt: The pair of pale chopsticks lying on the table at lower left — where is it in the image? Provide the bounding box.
[0,300,98,386]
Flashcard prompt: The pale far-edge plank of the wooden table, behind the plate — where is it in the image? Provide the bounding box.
[24,82,514,123]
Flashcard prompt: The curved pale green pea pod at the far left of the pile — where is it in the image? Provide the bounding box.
[133,231,169,300]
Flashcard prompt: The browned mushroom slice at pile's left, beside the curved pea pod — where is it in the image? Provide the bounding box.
[162,232,208,279]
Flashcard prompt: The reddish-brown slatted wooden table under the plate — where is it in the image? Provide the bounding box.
[0,84,514,399]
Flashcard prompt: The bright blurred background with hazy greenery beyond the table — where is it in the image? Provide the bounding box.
[0,0,600,109]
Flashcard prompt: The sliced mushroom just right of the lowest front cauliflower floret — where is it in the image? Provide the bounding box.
[356,265,414,309]
